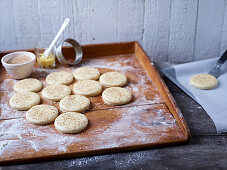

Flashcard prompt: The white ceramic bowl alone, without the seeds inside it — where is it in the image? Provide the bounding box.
[1,51,36,79]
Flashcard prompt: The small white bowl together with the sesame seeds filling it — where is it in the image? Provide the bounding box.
[1,51,36,79]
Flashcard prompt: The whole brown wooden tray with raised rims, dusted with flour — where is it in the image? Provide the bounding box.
[0,42,190,164]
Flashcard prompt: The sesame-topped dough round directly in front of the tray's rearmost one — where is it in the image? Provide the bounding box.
[73,80,102,97]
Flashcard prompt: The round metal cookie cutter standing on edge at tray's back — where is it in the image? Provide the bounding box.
[56,38,83,65]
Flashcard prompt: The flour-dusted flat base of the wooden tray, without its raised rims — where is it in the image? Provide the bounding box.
[0,56,182,160]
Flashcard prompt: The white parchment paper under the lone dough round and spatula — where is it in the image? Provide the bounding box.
[161,58,227,133]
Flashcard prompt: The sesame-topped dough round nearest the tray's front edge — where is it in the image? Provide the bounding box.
[54,112,88,133]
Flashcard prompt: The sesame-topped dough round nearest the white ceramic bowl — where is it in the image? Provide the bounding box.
[14,78,43,92]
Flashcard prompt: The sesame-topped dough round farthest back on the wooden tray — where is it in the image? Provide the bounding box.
[73,67,100,80]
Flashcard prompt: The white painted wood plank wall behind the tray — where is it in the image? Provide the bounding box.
[0,0,227,62]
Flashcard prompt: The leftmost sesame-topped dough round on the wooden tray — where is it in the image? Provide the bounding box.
[9,92,40,110]
